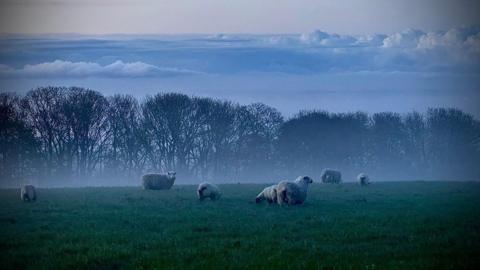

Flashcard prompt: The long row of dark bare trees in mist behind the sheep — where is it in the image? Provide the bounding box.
[0,87,480,185]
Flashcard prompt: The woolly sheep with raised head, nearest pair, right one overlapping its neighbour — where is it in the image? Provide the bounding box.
[277,176,313,205]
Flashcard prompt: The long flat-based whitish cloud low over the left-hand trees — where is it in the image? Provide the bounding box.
[0,60,201,78]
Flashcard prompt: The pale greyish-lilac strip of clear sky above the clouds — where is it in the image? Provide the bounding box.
[0,0,480,34]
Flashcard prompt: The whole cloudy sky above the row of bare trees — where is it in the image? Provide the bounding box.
[0,0,480,118]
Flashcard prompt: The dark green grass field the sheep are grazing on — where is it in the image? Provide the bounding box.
[0,182,480,269]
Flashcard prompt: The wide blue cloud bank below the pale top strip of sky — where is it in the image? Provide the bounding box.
[0,26,480,78]
